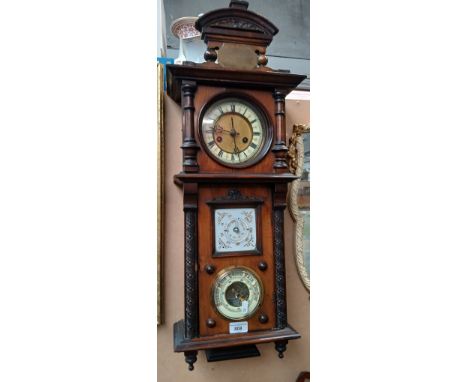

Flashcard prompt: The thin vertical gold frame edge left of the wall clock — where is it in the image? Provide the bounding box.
[156,63,165,325]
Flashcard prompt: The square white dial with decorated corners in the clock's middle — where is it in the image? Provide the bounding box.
[214,208,257,253]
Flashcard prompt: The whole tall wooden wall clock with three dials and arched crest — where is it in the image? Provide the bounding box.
[167,0,305,370]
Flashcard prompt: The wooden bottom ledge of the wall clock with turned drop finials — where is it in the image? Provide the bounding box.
[174,320,301,370]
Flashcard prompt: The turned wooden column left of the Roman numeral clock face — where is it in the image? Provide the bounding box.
[181,81,200,172]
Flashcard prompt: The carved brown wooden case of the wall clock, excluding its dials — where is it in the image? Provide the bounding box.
[167,1,305,370]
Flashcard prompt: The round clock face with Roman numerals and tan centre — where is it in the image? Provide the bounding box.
[201,98,267,166]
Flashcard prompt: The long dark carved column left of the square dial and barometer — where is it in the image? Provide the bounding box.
[184,184,198,338]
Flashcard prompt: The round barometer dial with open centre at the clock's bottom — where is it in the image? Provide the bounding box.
[212,267,263,320]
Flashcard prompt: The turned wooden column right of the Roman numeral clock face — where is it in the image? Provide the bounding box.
[272,89,288,172]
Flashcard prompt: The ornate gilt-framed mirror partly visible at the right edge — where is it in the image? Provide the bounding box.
[288,124,310,292]
